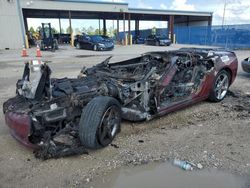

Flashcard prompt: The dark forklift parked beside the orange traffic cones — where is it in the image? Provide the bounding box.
[38,23,58,51]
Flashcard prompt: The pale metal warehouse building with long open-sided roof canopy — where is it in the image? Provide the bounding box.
[0,0,212,49]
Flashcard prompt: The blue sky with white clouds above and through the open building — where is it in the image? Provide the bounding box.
[28,0,250,33]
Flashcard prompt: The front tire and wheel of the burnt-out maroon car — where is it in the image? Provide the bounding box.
[79,96,121,149]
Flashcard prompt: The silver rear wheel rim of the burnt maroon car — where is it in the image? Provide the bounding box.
[215,73,229,100]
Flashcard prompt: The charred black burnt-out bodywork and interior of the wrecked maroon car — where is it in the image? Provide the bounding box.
[3,50,217,158]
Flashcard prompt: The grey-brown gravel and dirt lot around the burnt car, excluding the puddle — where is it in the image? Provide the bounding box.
[0,45,250,187]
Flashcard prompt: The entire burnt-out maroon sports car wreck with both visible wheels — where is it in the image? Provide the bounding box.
[3,49,238,159]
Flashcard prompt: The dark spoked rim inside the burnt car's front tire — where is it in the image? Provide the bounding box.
[97,106,120,146]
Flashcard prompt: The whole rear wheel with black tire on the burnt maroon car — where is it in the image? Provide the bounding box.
[209,70,231,102]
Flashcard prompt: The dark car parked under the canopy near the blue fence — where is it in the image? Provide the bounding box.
[145,35,172,46]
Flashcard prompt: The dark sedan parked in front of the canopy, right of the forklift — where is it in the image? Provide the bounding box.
[74,35,114,51]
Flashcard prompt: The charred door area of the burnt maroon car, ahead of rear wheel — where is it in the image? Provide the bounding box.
[157,53,209,113]
